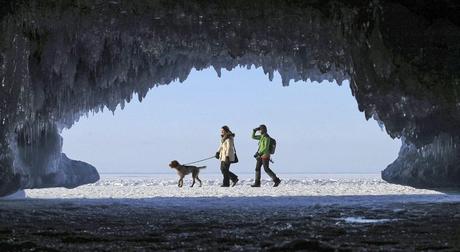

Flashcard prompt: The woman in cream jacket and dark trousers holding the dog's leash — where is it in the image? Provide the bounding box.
[216,126,238,187]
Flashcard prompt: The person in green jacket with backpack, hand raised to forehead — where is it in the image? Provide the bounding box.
[251,124,281,187]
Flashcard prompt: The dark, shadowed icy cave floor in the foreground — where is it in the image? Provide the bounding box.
[0,200,460,251]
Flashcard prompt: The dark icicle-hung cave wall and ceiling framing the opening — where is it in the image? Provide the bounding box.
[0,0,460,195]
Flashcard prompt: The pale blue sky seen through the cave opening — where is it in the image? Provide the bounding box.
[62,68,401,174]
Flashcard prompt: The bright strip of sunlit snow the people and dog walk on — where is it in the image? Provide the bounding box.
[25,174,460,206]
